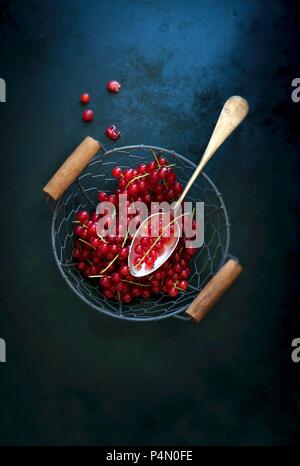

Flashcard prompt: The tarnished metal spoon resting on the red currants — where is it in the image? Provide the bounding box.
[128,96,249,277]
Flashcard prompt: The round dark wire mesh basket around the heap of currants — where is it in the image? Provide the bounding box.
[44,138,237,321]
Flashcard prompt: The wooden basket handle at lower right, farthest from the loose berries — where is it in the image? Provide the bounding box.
[186,259,242,322]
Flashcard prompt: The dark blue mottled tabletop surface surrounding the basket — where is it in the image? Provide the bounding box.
[0,0,300,445]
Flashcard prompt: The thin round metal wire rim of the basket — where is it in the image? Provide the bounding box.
[51,144,230,322]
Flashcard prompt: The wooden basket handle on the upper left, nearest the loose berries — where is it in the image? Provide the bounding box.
[43,136,101,201]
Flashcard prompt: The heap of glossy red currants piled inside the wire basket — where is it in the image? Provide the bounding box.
[73,156,197,304]
